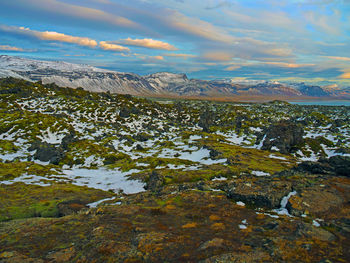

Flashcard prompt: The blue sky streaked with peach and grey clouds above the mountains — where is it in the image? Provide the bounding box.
[0,0,350,88]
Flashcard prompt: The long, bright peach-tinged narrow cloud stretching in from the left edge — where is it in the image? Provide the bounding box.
[0,25,97,47]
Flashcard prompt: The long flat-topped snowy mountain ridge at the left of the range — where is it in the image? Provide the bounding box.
[0,56,159,95]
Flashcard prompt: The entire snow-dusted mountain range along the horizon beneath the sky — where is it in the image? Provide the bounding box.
[0,55,350,99]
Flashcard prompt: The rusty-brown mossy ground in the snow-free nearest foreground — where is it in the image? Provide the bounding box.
[0,191,348,262]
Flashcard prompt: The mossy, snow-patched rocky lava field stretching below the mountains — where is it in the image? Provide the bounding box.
[0,75,350,262]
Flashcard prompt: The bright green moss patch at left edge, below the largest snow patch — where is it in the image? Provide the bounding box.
[0,183,113,221]
